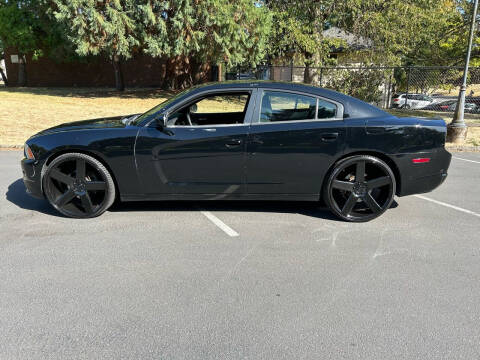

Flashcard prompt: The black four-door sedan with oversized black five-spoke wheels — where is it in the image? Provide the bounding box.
[22,82,451,221]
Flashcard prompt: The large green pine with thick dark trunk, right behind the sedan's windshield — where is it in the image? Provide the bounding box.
[142,0,271,88]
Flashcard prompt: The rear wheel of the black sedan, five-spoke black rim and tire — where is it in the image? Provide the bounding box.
[323,155,396,222]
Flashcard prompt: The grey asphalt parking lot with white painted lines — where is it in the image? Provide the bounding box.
[0,151,480,359]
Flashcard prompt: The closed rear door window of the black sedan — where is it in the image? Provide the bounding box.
[260,91,317,122]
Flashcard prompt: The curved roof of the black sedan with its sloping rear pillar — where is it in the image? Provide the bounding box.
[184,80,392,118]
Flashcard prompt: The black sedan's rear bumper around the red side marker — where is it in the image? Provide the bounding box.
[396,149,452,196]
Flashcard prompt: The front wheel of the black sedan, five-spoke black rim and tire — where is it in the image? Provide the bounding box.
[42,153,115,219]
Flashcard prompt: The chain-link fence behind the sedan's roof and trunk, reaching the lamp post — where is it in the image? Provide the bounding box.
[226,65,480,119]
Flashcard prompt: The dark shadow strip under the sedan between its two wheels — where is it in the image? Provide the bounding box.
[109,200,340,221]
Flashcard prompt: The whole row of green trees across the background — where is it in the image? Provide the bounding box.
[0,0,480,89]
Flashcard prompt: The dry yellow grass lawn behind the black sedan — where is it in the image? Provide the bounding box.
[0,87,480,146]
